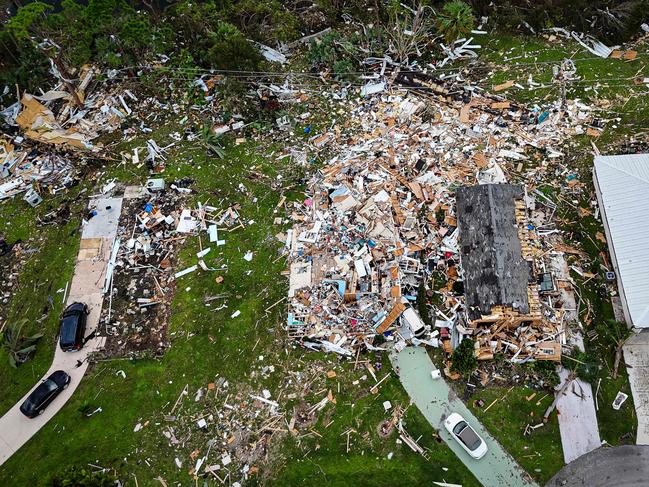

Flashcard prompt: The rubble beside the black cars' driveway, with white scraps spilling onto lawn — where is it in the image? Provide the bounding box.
[101,178,247,357]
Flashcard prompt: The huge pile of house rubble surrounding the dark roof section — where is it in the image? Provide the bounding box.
[280,88,592,361]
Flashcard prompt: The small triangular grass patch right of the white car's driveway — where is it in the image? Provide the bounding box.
[468,387,564,485]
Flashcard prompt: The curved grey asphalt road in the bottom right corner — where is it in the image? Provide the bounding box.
[546,445,649,487]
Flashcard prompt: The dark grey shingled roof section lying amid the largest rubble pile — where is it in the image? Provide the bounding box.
[457,184,530,320]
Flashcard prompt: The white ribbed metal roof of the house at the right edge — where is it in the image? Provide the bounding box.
[593,154,649,328]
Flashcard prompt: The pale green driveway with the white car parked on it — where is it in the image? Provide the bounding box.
[390,347,536,487]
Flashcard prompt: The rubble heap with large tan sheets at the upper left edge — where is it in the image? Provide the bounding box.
[0,68,138,206]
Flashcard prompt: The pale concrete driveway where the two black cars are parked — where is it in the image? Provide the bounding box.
[0,198,122,465]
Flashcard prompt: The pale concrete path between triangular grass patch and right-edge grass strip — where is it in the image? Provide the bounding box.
[557,369,602,463]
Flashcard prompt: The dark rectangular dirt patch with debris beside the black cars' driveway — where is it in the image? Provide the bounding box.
[101,191,186,357]
